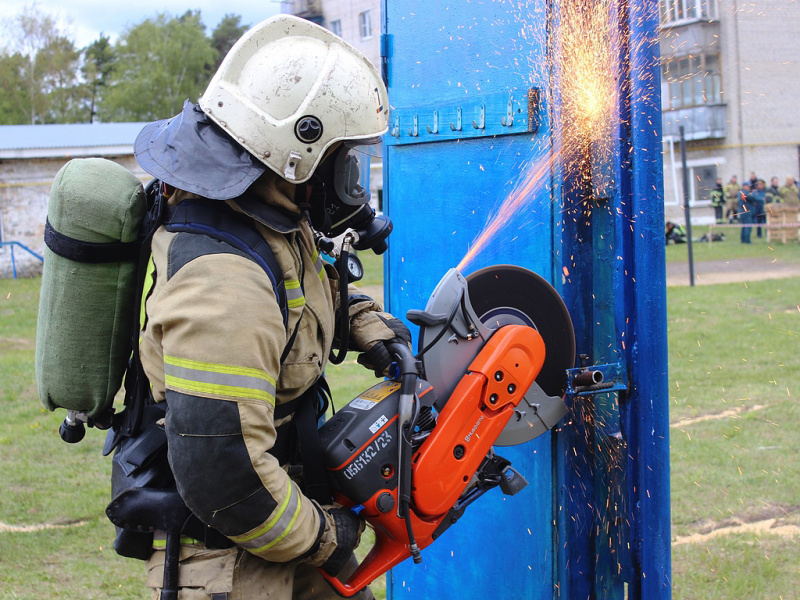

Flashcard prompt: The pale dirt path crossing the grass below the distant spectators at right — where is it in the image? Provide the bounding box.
[667,258,800,286]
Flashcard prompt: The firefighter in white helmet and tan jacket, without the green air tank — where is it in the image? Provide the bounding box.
[135,15,411,600]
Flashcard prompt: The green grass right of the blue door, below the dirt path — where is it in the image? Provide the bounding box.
[667,276,800,600]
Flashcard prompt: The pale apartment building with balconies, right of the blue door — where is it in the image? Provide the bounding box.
[660,0,800,222]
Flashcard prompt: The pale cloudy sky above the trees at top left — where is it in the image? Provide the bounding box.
[0,0,281,47]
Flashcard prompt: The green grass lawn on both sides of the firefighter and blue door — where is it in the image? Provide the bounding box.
[0,241,800,600]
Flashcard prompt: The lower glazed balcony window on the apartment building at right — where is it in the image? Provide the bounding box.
[661,54,722,110]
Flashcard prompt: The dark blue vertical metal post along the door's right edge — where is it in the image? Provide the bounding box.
[623,0,671,599]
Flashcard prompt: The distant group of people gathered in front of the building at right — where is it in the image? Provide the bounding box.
[711,172,800,244]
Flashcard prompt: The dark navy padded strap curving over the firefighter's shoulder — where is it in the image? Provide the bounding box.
[164,198,289,327]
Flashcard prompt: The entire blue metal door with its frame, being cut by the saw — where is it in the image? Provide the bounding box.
[382,0,670,600]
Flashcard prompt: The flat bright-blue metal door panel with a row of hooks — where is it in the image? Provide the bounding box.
[384,2,554,600]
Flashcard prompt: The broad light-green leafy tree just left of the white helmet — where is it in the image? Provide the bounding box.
[97,11,214,121]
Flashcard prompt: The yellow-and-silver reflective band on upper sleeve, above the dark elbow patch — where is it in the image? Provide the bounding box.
[164,355,275,405]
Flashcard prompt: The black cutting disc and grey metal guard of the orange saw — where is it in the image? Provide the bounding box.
[407,265,575,446]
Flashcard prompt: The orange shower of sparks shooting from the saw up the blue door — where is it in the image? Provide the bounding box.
[458,0,653,269]
